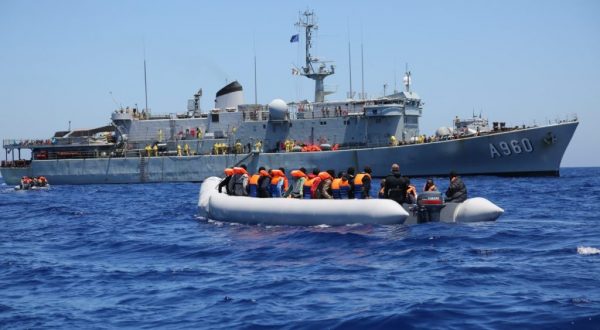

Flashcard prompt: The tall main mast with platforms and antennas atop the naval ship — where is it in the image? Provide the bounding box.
[296,10,335,102]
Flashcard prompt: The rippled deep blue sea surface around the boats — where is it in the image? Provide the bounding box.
[0,168,600,329]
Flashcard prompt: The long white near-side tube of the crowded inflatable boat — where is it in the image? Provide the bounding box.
[198,177,408,226]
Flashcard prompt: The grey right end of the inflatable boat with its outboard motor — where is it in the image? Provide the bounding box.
[404,191,504,225]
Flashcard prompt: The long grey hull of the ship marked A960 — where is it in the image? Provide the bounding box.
[2,121,578,185]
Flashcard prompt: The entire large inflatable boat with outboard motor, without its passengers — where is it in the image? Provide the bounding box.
[198,177,504,226]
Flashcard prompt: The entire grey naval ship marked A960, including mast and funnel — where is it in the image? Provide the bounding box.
[0,11,578,185]
